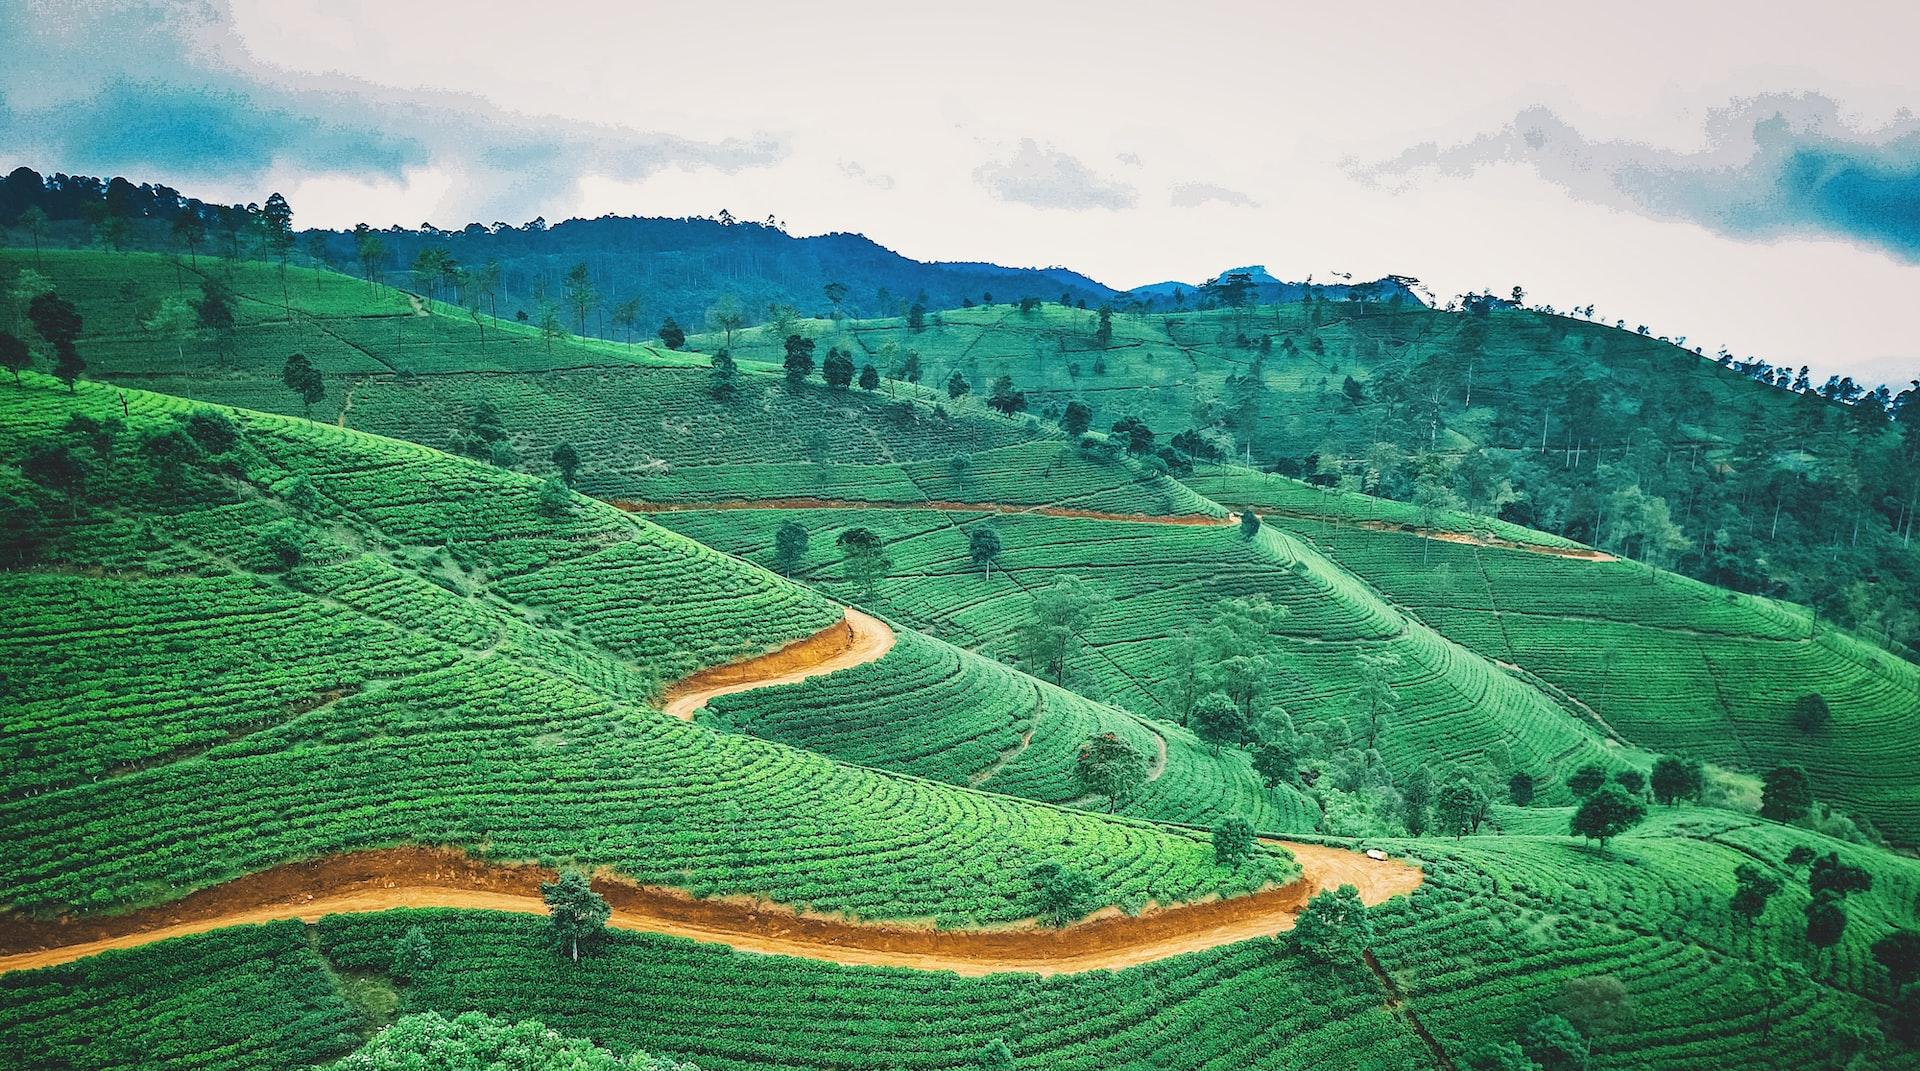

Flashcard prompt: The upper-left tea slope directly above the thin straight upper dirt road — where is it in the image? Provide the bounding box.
[15,251,1208,512]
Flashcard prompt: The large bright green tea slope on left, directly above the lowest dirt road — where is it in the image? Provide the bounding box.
[0,376,1288,921]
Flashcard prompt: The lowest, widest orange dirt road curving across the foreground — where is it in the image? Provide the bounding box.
[0,841,1421,975]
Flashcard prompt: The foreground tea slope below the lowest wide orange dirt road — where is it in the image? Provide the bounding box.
[0,808,1920,1071]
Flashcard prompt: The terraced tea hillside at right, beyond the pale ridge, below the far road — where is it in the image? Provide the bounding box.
[1198,476,1920,843]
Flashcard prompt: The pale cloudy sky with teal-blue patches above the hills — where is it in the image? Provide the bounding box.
[0,0,1920,386]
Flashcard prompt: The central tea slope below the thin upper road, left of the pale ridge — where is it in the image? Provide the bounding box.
[662,511,1634,802]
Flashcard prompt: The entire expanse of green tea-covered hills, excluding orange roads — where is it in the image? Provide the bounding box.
[0,250,1920,1071]
